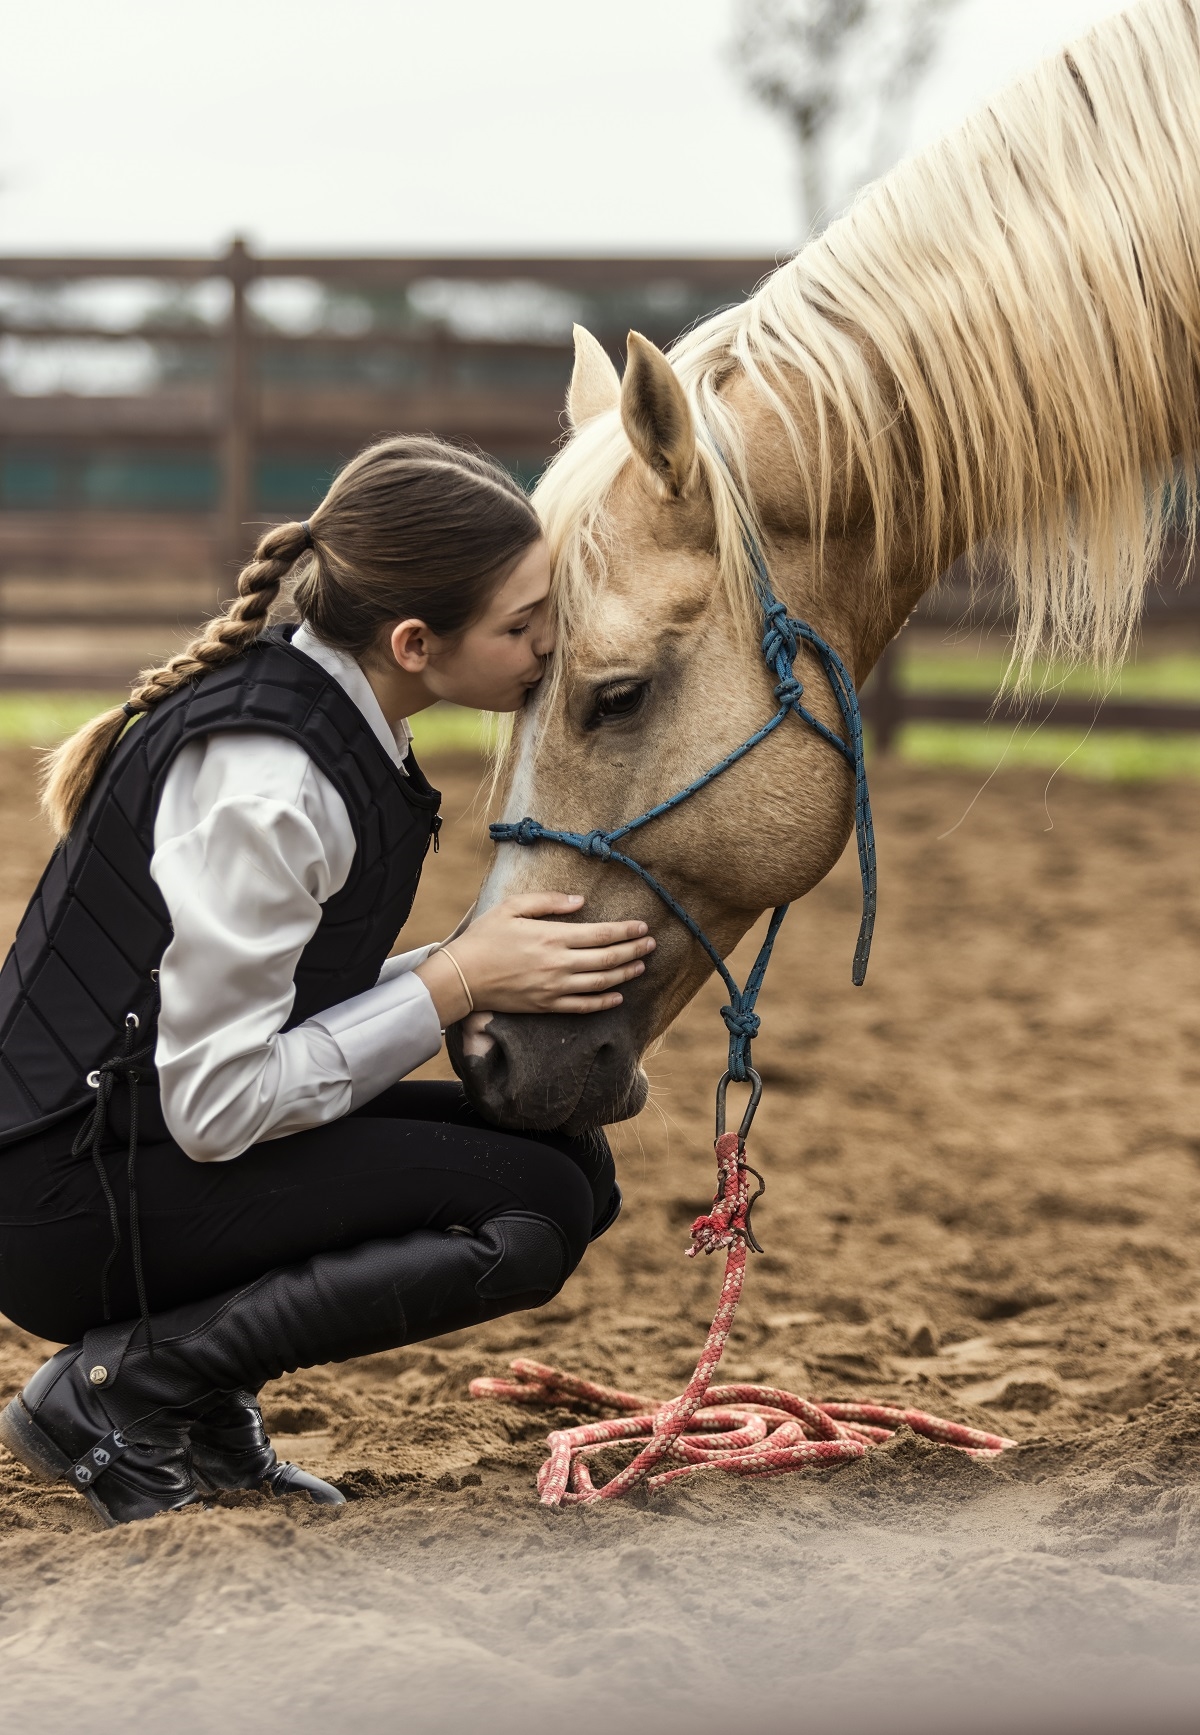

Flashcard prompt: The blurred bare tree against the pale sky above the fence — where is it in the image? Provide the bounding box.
[735,0,959,234]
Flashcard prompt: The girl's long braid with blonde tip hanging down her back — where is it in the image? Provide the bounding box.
[40,524,312,838]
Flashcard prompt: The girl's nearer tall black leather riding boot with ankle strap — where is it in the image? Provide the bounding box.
[0,1211,576,1523]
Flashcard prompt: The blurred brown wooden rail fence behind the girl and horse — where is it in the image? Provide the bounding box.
[0,241,1200,732]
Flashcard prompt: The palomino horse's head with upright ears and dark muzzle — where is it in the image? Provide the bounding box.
[451,331,908,1131]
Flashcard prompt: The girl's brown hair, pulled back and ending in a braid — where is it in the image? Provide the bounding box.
[42,434,541,838]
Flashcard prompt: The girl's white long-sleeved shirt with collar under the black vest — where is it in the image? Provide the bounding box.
[151,626,442,1162]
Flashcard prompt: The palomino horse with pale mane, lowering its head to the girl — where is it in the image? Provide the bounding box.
[451,0,1200,1131]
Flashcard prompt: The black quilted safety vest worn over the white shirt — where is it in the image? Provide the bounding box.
[0,626,440,1145]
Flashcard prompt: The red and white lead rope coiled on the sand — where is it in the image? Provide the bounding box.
[470,1133,1016,1506]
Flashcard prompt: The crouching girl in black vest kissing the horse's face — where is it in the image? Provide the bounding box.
[0,437,654,1523]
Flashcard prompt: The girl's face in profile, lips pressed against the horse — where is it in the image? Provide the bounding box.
[397,540,553,711]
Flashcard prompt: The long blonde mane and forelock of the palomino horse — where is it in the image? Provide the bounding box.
[536,0,1200,670]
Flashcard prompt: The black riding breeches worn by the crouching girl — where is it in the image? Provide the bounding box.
[0,1083,621,1343]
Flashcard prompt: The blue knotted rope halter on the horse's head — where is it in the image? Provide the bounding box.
[491,503,876,1082]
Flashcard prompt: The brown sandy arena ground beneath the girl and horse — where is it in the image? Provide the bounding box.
[0,753,1200,1735]
